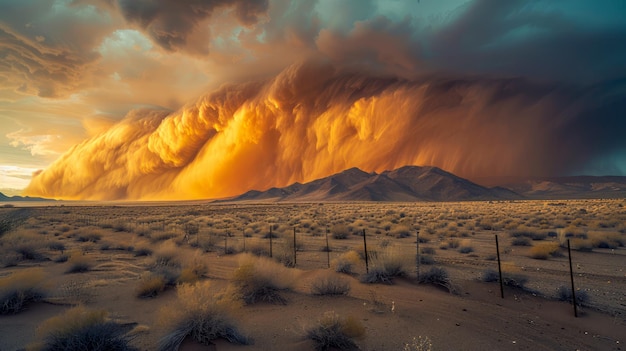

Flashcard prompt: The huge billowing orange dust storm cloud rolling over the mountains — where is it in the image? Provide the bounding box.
[26,60,626,199]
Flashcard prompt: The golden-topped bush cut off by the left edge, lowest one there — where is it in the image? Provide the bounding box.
[0,268,47,314]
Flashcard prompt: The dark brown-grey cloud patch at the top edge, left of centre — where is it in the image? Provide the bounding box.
[118,0,268,54]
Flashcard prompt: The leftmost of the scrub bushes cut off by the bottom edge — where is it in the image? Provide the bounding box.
[32,306,137,351]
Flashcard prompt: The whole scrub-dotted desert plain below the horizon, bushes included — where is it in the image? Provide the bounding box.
[0,199,626,351]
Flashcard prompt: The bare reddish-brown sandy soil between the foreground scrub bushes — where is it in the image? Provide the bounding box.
[0,202,626,351]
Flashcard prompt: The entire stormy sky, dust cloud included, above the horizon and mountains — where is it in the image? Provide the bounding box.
[0,0,626,200]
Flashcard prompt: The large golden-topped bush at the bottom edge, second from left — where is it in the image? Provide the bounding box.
[159,281,252,351]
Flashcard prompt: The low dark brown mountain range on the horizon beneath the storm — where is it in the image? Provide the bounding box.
[225,166,626,202]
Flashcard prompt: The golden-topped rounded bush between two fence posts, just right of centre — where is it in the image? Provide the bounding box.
[361,248,414,284]
